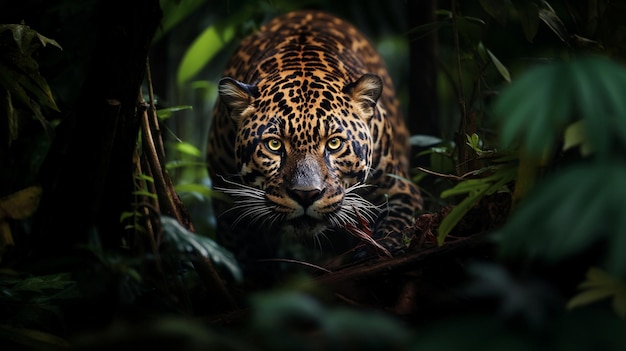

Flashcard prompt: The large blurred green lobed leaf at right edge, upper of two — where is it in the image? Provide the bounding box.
[494,56,626,158]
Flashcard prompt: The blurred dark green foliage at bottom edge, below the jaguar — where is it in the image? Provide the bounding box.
[250,292,412,350]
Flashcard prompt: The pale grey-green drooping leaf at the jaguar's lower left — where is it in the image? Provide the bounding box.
[161,216,243,282]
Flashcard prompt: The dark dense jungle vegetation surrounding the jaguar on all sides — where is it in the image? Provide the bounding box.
[0,0,626,350]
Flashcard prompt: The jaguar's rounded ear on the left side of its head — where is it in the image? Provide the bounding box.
[218,77,259,122]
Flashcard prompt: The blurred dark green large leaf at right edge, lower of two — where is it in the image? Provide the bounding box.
[496,162,626,276]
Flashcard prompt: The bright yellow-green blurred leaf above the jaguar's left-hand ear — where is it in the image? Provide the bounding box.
[176,25,235,86]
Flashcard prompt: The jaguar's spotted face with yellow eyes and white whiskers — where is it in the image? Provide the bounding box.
[214,75,382,235]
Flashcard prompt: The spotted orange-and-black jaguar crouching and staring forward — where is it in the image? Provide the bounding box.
[207,7,423,272]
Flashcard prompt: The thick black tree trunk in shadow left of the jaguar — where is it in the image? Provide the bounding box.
[32,0,161,257]
